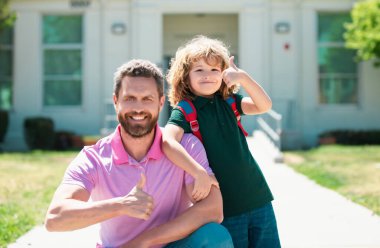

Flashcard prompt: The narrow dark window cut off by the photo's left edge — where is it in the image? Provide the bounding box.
[0,28,13,110]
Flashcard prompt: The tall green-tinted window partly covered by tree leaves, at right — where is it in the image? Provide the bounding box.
[318,13,358,104]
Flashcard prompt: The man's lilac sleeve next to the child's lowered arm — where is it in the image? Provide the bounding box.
[181,134,214,184]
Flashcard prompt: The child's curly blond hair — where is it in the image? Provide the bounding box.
[166,35,238,107]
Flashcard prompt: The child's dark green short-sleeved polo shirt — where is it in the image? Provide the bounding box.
[168,95,273,217]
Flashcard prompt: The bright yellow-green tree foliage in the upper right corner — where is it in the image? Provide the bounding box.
[344,0,380,66]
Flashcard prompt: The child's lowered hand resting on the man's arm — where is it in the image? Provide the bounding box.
[191,171,219,201]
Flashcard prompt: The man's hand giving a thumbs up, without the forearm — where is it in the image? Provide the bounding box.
[119,173,154,220]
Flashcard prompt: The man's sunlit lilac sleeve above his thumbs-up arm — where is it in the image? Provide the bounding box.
[62,150,97,193]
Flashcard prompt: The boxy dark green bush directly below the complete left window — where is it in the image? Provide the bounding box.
[24,117,55,150]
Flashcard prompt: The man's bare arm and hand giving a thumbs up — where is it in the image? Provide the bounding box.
[45,174,153,231]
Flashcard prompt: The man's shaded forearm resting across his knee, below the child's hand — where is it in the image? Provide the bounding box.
[123,178,223,248]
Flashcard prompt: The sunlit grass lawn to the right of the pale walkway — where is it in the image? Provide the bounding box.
[285,145,380,215]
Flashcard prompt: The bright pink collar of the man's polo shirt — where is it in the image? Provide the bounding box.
[111,124,163,165]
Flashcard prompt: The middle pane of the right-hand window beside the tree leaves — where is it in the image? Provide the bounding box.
[318,47,357,73]
